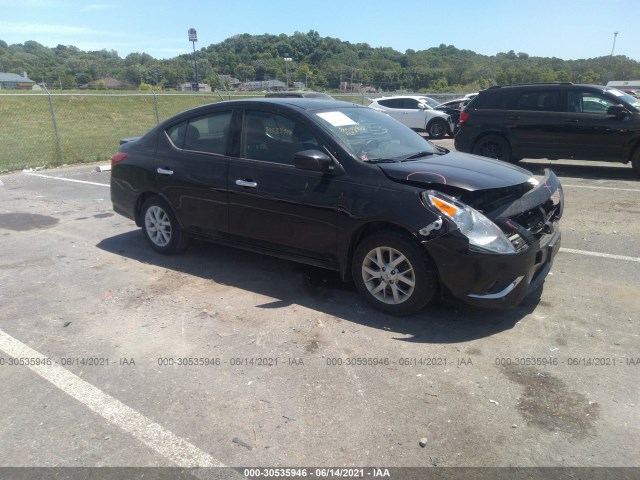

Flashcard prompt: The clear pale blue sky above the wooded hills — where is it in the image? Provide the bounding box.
[0,0,640,61]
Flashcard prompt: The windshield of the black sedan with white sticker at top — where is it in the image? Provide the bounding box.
[315,107,441,162]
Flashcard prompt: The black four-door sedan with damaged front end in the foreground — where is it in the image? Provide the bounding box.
[111,98,563,315]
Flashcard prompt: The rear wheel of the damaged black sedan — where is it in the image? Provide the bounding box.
[141,197,189,255]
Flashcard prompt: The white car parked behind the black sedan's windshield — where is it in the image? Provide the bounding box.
[369,96,454,139]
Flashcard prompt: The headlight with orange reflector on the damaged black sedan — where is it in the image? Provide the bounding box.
[424,190,516,254]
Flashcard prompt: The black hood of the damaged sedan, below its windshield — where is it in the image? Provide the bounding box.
[378,152,533,191]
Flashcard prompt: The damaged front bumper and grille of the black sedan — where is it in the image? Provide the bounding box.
[423,171,564,307]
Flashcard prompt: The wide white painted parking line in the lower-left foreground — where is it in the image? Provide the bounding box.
[0,330,225,468]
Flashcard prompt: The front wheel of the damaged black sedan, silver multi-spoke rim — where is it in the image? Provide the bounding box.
[352,231,437,316]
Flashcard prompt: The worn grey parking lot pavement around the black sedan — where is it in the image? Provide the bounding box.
[0,143,640,478]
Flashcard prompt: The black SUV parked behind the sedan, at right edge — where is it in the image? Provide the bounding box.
[455,83,640,175]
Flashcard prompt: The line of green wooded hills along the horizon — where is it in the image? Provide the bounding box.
[0,30,640,93]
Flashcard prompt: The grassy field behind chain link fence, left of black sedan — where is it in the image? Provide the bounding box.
[0,91,460,172]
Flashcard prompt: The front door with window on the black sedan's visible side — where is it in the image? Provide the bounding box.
[229,109,339,261]
